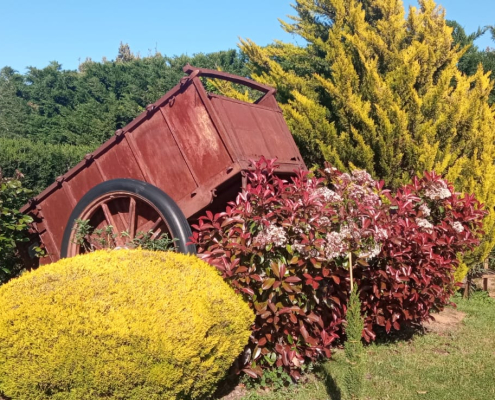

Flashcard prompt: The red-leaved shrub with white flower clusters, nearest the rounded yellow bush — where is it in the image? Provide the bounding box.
[193,159,392,379]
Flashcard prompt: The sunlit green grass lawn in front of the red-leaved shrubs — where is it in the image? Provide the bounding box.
[238,294,495,400]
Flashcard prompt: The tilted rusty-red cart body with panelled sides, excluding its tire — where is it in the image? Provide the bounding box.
[21,65,304,263]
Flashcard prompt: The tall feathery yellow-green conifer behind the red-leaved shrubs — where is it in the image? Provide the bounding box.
[235,0,495,279]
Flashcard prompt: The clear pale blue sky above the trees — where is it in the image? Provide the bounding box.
[0,0,495,72]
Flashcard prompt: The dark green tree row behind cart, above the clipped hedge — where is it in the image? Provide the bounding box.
[0,46,245,146]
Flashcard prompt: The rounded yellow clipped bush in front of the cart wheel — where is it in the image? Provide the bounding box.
[0,250,254,400]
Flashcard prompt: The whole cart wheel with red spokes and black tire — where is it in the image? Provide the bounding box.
[61,179,196,257]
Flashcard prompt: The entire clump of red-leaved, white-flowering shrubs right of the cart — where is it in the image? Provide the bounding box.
[192,158,483,379]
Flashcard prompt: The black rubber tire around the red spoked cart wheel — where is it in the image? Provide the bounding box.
[60,179,196,258]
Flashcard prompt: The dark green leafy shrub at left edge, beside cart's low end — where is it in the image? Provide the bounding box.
[0,169,32,284]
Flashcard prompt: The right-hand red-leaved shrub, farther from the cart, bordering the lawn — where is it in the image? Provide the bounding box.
[355,173,485,341]
